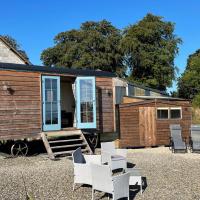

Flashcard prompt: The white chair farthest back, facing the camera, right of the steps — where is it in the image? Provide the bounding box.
[101,142,127,170]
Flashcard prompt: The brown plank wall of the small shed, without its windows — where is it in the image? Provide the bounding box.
[119,100,192,147]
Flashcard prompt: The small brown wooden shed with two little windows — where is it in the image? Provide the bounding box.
[119,97,192,147]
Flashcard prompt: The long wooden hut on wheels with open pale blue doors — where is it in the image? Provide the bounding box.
[0,63,115,158]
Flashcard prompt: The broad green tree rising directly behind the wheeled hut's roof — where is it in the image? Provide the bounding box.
[41,20,124,76]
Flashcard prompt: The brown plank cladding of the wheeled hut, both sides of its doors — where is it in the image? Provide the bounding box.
[0,70,114,140]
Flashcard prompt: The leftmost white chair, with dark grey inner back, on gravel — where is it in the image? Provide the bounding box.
[72,147,101,191]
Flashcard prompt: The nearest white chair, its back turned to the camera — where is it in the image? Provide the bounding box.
[91,164,129,200]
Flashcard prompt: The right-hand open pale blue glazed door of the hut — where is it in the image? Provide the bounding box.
[76,77,96,129]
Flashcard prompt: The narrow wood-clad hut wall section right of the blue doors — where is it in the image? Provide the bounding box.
[96,77,114,133]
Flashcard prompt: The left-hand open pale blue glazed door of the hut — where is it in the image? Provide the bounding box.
[42,76,61,131]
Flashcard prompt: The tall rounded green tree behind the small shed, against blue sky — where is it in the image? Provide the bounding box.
[121,14,181,90]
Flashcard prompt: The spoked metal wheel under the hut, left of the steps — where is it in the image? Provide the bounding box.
[11,141,28,157]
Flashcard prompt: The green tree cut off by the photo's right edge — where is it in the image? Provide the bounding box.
[178,49,200,99]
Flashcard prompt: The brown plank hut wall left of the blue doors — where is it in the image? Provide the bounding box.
[0,71,41,140]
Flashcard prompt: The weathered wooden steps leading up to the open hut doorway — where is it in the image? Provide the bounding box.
[41,129,92,160]
